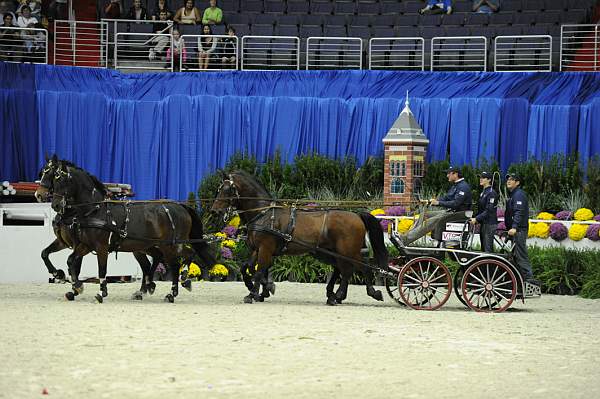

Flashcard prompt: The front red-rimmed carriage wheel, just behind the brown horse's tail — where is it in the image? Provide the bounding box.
[398,257,452,310]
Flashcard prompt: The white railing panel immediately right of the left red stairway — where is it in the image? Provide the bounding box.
[115,33,173,71]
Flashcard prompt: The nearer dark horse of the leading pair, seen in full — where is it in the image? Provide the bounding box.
[40,161,216,303]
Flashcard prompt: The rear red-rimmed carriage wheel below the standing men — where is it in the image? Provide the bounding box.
[462,259,517,312]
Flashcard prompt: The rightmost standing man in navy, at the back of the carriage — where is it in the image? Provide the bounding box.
[504,173,540,285]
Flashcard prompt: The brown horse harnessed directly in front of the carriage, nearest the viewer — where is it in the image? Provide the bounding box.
[211,170,388,305]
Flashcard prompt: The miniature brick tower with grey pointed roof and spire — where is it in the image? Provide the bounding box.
[383,92,429,205]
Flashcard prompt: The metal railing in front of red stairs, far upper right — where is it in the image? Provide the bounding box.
[560,24,600,71]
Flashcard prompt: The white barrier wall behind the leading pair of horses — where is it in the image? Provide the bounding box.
[0,203,141,283]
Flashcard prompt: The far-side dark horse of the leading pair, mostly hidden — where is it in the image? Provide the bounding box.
[34,155,178,300]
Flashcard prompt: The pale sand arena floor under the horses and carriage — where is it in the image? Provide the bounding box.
[0,282,600,399]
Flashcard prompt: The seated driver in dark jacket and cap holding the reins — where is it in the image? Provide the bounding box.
[398,166,471,245]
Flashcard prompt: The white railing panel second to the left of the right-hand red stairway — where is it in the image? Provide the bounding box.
[431,36,487,71]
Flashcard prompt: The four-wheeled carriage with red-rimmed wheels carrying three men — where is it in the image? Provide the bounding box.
[380,211,541,312]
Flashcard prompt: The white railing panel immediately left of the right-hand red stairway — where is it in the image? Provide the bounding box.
[494,35,552,72]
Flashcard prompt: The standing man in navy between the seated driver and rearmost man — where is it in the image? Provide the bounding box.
[471,172,498,253]
